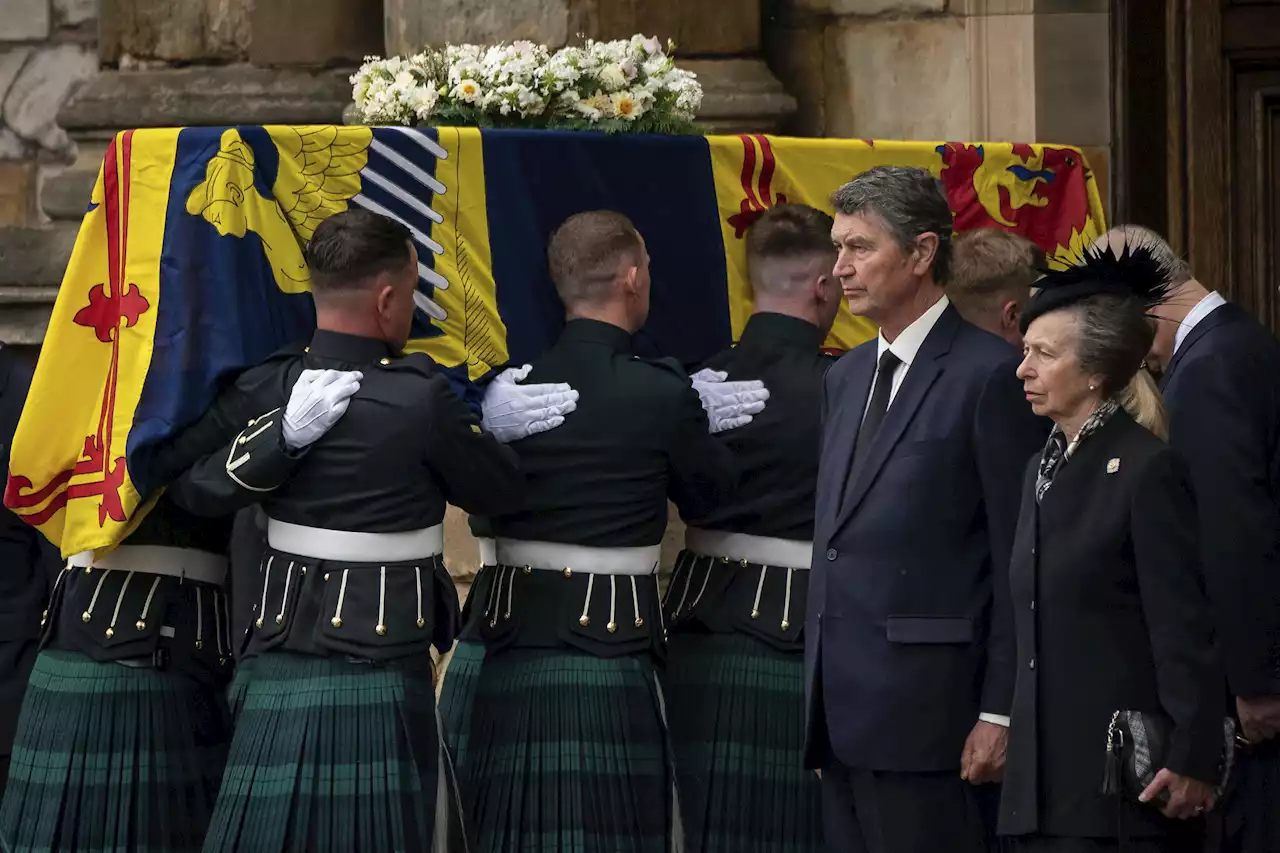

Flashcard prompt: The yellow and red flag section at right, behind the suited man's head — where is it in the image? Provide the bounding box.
[708,134,1105,350]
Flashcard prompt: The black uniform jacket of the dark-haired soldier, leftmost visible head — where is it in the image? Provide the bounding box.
[140,330,524,660]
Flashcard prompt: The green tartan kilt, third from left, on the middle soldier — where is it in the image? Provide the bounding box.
[440,640,681,853]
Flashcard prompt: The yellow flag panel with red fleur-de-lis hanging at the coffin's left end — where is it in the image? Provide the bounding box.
[5,129,178,556]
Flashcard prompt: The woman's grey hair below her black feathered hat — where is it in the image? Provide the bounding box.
[1065,295,1156,397]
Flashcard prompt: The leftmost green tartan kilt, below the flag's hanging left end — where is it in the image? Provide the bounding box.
[0,649,230,853]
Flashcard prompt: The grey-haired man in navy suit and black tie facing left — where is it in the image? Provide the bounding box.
[805,167,1044,853]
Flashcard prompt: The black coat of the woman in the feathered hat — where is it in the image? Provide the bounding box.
[1000,410,1226,838]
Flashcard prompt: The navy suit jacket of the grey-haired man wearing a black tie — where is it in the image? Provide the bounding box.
[805,307,1047,772]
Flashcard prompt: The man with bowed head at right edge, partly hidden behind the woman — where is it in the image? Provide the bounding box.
[1100,225,1280,853]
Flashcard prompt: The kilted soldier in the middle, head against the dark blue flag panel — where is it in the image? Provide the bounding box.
[440,211,767,853]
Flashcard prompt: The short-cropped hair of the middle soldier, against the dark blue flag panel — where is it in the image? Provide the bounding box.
[547,210,644,305]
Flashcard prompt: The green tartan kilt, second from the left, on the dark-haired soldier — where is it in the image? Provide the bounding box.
[204,652,467,853]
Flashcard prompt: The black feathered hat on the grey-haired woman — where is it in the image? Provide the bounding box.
[1020,241,1172,334]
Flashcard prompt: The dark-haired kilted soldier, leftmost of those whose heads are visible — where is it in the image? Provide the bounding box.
[144,210,570,853]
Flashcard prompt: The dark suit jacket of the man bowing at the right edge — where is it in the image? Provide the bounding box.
[1162,305,1280,697]
